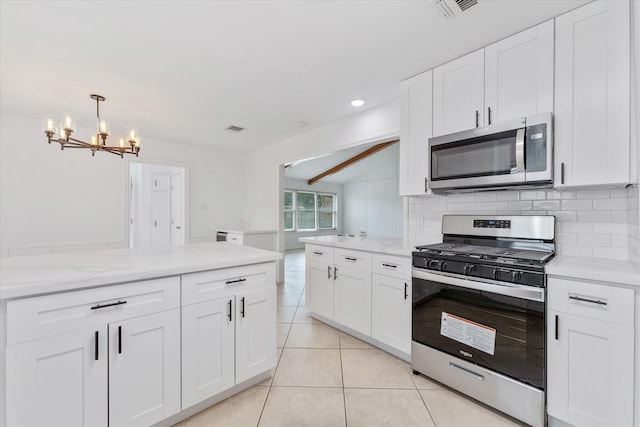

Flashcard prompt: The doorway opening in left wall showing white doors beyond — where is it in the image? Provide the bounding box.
[129,162,186,248]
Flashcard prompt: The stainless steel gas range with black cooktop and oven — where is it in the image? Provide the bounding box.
[411,215,555,426]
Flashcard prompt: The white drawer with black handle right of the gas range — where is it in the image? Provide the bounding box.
[547,277,635,325]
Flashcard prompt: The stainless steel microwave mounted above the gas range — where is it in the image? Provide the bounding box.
[429,113,553,192]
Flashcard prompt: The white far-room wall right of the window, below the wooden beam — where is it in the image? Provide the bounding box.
[344,144,403,239]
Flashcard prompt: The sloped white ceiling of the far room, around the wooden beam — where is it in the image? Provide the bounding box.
[284,143,399,184]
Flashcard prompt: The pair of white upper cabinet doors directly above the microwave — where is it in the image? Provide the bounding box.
[433,21,553,136]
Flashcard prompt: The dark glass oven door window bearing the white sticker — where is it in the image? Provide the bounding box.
[412,278,545,389]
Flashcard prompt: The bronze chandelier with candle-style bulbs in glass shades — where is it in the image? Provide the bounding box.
[44,94,140,158]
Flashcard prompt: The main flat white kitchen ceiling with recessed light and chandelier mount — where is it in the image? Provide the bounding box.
[0,0,587,151]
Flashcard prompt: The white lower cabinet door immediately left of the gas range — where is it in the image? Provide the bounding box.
[371,274,411,354]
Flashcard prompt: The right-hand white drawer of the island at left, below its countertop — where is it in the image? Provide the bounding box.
[182,262,276,305]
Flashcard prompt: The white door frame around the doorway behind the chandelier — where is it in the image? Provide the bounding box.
[124,159,191,248]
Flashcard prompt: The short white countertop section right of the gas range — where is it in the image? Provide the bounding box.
[545,255,640,286]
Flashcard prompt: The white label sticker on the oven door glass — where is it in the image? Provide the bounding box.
[440,312,496,356]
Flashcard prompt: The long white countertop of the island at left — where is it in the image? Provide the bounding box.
[0,242,282,299]
